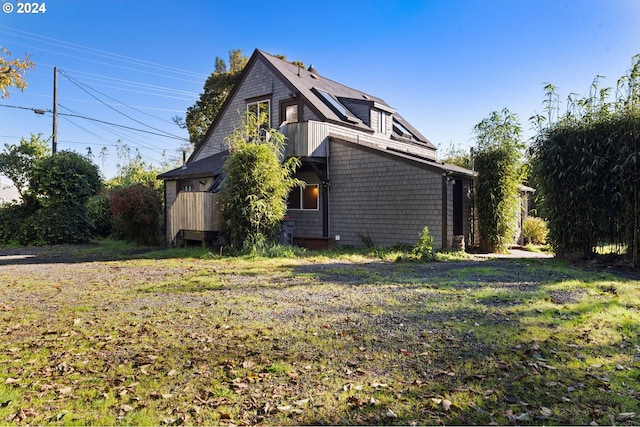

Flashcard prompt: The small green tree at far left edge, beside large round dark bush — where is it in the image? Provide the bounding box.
[0,134,49,200]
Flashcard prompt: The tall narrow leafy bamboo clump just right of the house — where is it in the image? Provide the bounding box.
[474,109,525,252]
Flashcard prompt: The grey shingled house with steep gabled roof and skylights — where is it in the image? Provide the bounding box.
[158,50,475,248]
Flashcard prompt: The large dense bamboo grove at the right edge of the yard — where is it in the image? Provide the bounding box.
[531,55,640,266]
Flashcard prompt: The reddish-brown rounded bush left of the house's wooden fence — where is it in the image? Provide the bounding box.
[109,184,162,245]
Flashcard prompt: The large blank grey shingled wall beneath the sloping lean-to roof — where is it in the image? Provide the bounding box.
[329,141,443,247]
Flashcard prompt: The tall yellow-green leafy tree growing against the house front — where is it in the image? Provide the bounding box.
[222,113,302,252]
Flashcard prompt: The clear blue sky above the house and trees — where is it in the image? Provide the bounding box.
[0,0,640,178]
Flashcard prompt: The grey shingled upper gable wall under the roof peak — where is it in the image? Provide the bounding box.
[193,60,294,160]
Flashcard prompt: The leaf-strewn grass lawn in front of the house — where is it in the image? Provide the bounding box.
[0,242,640,425]
